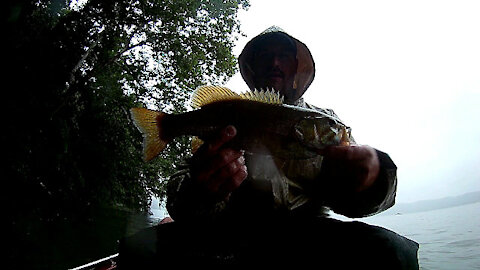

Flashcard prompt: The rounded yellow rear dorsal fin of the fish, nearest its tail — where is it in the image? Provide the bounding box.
[192,86,241,108]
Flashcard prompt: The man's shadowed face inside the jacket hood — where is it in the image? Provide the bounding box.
[252,40,298,100]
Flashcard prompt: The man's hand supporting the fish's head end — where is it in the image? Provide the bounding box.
[318,145,380,193]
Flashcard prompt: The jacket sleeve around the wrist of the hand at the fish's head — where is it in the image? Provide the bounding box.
[327,150,397,218]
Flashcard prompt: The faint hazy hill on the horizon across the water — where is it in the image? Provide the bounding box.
[380,191,480,215]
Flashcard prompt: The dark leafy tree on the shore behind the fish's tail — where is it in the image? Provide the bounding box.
[2,0,249,266]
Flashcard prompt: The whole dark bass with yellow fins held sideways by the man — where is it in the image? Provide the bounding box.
[130,86,351,161]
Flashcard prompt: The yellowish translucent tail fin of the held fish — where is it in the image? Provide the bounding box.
[130,108,167,161]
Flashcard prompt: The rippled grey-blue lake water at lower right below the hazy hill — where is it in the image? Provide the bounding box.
[359,203,480,270]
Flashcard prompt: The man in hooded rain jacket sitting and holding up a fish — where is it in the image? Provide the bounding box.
[118,27,418,269]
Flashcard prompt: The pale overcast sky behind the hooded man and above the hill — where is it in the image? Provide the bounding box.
[227,0,480,202]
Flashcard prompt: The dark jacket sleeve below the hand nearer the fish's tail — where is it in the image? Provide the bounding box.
[166,160,226,221]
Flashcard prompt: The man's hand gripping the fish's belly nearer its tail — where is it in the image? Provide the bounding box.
[191,126,247,199]
